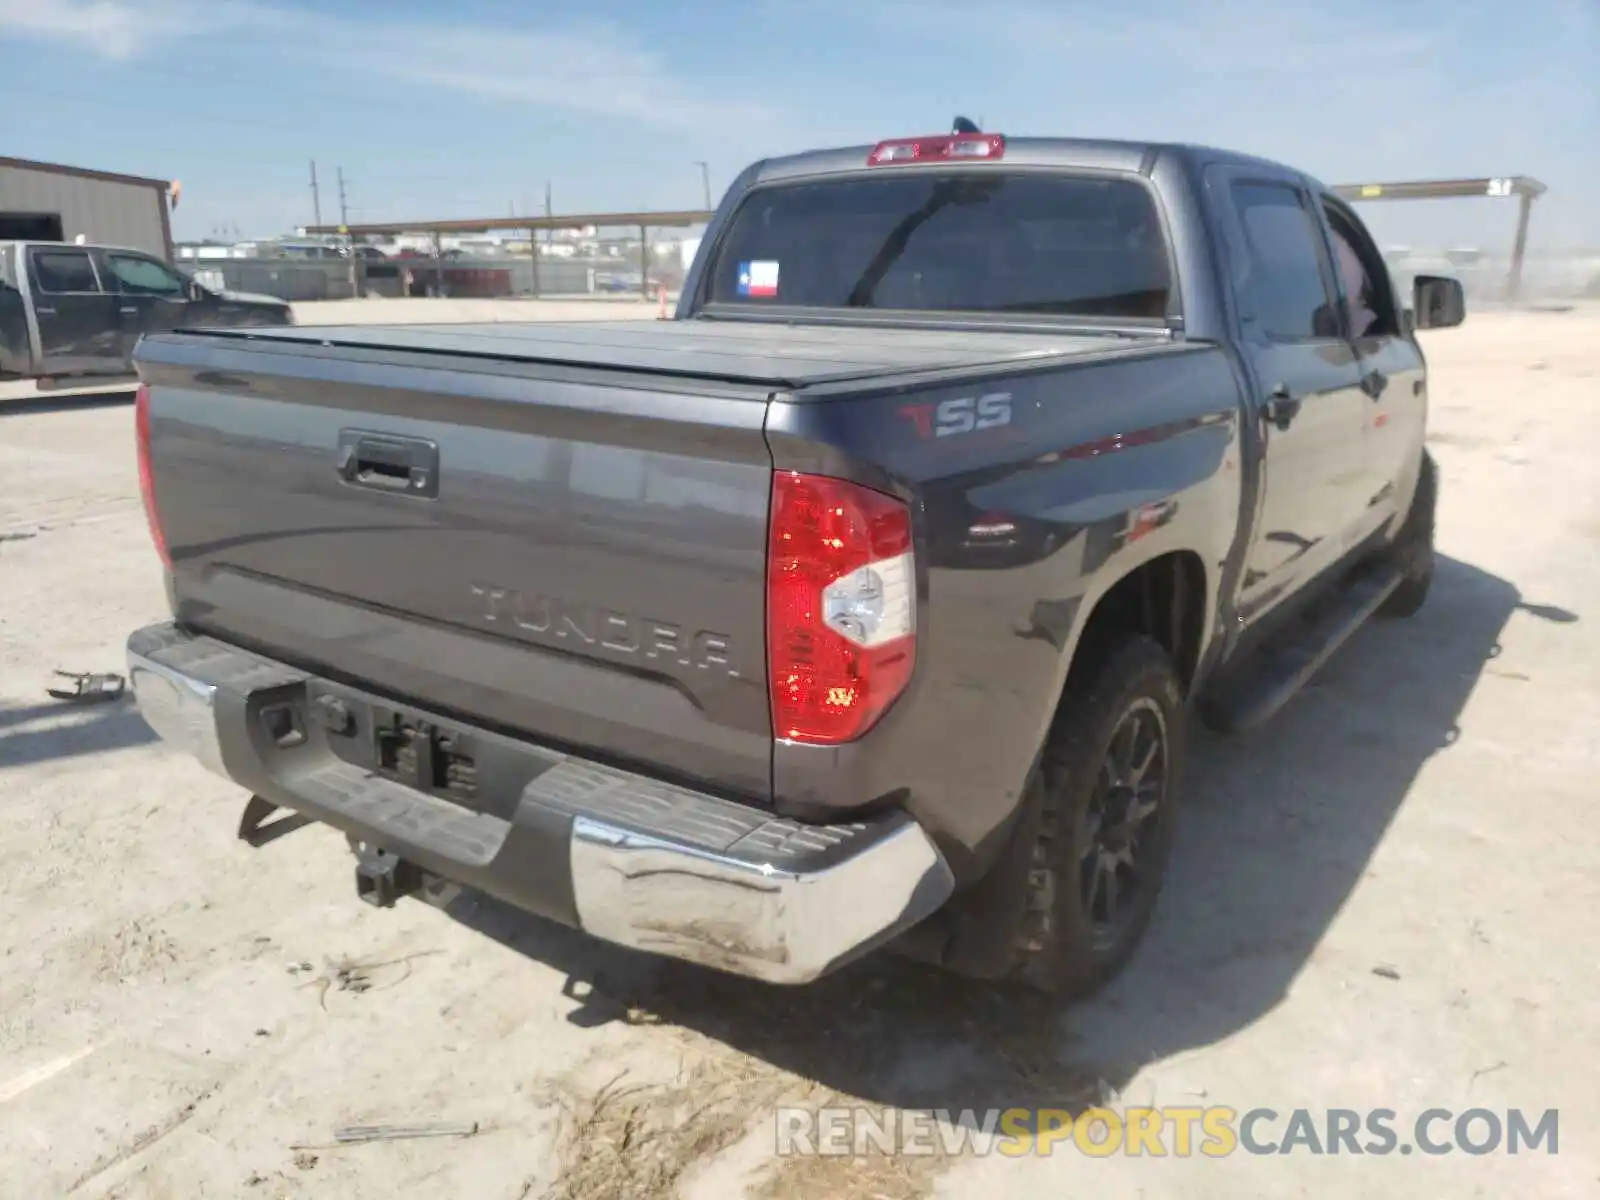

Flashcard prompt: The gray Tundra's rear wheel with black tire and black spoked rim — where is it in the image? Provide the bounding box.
[1013,637,1187,1000]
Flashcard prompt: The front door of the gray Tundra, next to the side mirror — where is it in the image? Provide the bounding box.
[1322,195,1427,530]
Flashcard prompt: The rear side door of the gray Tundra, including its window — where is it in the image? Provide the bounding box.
[1208,166,1368,622]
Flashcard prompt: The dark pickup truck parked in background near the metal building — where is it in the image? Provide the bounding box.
[0,242,293,390]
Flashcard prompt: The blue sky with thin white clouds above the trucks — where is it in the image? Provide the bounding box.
[0,0,1600,248]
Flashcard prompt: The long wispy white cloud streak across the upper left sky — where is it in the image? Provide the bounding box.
[0,0,770,131]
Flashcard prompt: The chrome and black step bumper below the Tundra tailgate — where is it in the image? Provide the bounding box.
[128,624,954,984]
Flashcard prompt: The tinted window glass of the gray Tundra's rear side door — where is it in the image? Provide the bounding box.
[1232,182,1339,341]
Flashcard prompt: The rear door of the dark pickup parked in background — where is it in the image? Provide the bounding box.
[27,246,128,374]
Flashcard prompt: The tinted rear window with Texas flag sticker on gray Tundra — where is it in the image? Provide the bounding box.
[709,171,1171,318]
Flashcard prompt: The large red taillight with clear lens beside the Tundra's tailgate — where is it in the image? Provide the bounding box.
[766,470,917,746]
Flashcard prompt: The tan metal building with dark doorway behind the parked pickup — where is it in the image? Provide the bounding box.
[0,158,173,262]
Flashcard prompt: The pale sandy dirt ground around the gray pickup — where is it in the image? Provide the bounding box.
[0,302,1600,1200]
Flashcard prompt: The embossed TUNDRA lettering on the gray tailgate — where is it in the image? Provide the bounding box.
[470,584,739,678]
